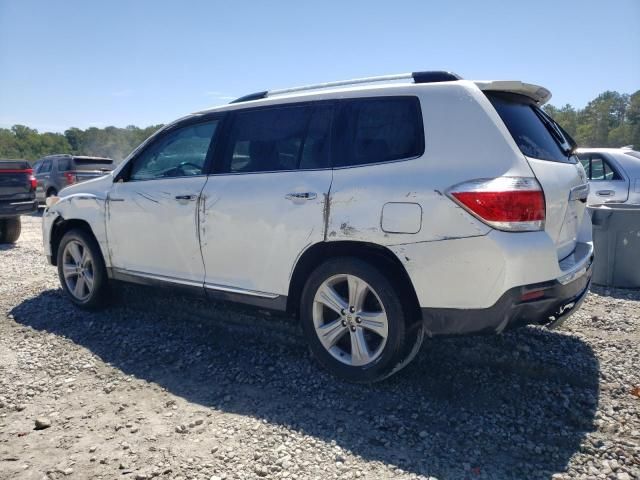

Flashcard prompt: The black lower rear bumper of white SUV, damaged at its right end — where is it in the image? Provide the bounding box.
[422,256,593,336]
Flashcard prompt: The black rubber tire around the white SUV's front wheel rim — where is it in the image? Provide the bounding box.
[57,229,109,310]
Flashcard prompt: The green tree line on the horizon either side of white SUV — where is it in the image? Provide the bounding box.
[0,90,640,161]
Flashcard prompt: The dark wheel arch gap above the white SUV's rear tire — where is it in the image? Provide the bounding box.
[287,240,421,319]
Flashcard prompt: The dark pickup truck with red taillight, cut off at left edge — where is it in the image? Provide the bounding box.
[0,159,38,243]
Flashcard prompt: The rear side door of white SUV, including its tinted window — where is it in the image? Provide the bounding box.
[200,102,333,298]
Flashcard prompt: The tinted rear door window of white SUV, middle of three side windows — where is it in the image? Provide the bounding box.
[225,105,332,173]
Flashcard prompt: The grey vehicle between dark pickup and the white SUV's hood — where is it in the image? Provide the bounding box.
[34,155,115,202]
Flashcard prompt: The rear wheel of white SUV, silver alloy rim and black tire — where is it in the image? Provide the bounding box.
[300,258,423,383]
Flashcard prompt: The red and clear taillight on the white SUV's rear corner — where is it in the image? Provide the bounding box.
[447,177,545,232]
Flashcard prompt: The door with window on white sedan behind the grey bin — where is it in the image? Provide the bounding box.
[579,153,629,205]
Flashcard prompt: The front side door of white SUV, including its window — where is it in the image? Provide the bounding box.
[107,120,218,285]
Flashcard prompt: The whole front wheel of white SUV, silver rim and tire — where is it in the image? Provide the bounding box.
[58,230,108,309]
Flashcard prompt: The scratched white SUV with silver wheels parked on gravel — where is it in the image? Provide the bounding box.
[43,72,593,382]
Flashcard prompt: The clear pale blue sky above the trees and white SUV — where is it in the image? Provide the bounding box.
[0,0,640,131]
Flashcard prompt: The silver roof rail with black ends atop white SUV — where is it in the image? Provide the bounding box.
[230,70,462,103]
